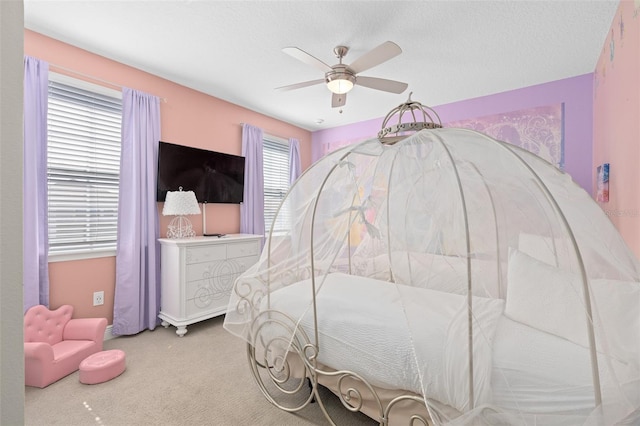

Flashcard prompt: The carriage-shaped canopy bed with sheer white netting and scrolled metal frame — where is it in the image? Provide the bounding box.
[224,99,640,426]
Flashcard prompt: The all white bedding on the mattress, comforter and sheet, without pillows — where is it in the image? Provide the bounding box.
[263,273,632,413]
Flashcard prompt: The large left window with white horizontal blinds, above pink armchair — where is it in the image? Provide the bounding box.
[47,74,122,257]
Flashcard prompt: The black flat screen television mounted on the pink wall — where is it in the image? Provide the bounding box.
[157,141,245,204]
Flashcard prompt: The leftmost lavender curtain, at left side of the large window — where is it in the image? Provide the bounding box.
[23,56,49,312]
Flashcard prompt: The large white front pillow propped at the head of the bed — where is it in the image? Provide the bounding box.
[505,249,640,368]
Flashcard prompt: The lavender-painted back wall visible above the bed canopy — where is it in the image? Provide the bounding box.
[311,73,593,194]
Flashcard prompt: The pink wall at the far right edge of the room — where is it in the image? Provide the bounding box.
[592,0,640,257]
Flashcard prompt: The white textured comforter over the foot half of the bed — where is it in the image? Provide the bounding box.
[264,273,503,411]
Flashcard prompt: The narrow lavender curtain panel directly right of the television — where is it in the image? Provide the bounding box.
[240,124,264,235]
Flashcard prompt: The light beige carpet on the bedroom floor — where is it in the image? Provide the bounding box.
[25,317,378,426]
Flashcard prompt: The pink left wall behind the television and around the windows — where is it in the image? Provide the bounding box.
[24,30,311,323]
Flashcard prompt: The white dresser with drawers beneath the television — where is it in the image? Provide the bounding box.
[158,234,262,337]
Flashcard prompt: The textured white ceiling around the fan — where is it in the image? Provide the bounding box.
[24,0,619,130]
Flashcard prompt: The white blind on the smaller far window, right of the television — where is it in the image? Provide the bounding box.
[262,138,291,234]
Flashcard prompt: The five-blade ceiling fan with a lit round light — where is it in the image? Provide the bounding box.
[277,41,407,108]
